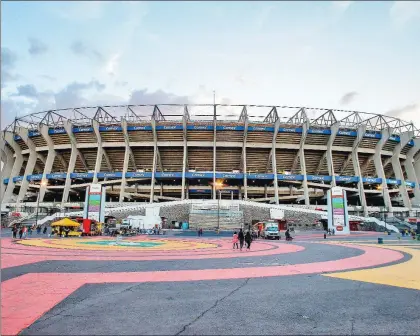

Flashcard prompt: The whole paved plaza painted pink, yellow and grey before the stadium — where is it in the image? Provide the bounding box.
[1,232,420,335]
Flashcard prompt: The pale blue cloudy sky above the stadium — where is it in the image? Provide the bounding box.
[1,1,420,128]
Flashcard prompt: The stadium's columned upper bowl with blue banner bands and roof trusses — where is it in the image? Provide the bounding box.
[1,104,420,208]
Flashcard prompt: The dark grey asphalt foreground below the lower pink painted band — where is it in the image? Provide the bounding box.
[22,275,420,335]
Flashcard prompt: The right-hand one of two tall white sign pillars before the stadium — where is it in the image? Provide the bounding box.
[328,187,350,235]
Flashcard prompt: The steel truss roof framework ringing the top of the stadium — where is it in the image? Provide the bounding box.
[5,104,420,137]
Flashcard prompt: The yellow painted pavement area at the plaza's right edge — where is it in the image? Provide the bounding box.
[322,243,420,290]
